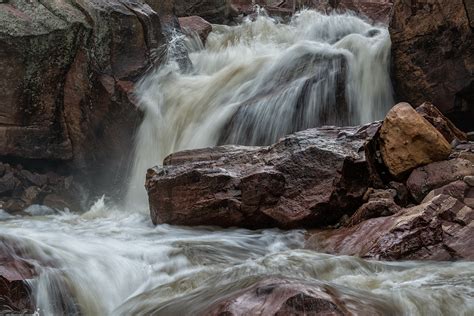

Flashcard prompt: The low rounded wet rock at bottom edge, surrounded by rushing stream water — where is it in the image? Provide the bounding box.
[199,278,381,316]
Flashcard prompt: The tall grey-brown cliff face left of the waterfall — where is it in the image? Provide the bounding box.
[0,0,168,198]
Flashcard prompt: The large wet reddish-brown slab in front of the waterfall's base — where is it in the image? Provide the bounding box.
[146,123,379,228]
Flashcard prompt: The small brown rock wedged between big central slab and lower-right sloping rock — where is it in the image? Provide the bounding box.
[346,189,402,227]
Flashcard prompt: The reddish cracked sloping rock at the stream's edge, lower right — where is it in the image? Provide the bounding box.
[307,195,474,260]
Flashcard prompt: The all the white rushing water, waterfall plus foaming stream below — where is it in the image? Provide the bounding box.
[0,11,474,316]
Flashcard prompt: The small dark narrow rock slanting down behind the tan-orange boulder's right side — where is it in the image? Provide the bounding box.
[416,102,467,143]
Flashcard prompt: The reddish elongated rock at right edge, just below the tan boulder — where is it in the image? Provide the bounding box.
[407,159,474,202]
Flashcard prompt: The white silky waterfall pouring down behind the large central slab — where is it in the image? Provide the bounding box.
[127,10,393,208]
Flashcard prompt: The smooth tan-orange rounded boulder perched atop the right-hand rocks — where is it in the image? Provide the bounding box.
[380,103,451,177]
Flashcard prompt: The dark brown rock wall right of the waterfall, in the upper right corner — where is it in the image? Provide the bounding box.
[390,0,474,130]
